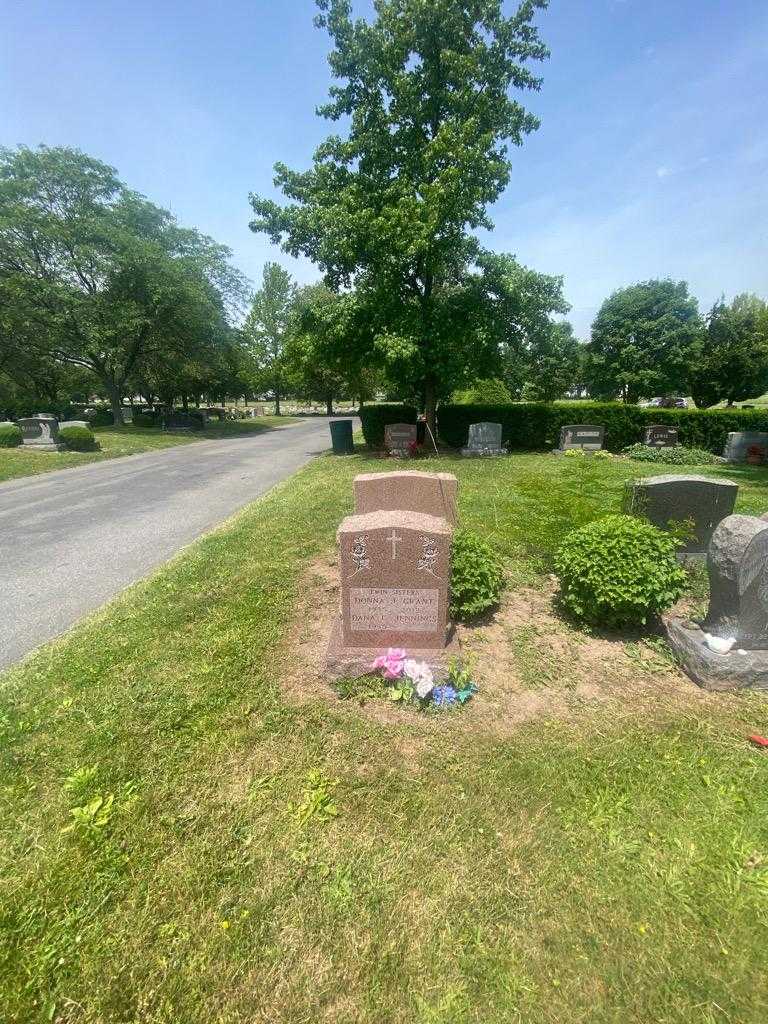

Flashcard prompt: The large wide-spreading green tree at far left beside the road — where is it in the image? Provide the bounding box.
[0,146,244,423]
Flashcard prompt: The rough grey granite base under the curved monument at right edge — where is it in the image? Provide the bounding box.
[662,615,768,692]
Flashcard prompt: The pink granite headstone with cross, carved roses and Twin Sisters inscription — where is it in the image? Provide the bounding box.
[327,511,453,676]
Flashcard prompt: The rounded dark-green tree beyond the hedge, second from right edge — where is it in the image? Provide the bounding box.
[585,280,702,402]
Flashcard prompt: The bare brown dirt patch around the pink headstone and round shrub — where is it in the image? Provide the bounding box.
[283,553,722,736]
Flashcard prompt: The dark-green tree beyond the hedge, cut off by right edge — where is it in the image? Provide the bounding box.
[691,295,768,407]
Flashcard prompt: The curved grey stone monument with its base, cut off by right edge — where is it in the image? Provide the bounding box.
[663,515,768,690]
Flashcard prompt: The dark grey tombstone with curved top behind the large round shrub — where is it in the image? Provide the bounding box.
[625,473,738,559]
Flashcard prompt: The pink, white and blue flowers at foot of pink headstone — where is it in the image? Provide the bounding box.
[372,647,477,710]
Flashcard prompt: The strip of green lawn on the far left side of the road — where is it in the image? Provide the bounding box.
[0,416,296,482]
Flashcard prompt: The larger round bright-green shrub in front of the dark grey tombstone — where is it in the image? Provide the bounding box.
[555,515,687,628]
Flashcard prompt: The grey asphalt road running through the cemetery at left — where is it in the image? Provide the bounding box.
[0,417,342,669]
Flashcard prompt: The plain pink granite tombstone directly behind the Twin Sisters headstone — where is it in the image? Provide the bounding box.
[352,470,459,525]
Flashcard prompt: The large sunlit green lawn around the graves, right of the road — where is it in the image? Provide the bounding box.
[0,455,768,1024]
